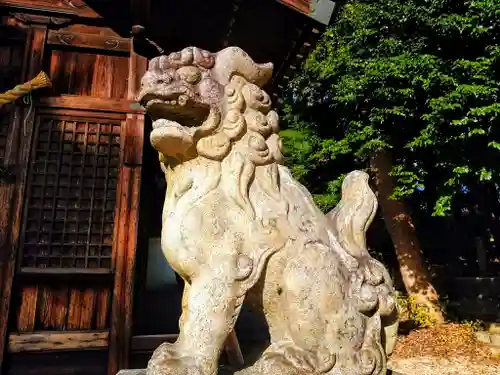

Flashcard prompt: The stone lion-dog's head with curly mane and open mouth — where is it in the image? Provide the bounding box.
[139,47,279,164]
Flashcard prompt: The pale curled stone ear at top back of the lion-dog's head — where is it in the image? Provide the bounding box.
[212,47,273,87]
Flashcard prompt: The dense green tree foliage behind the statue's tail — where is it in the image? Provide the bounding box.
[282,0,500,216]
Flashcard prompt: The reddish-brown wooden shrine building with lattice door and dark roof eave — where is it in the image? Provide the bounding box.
[0,0,335,375]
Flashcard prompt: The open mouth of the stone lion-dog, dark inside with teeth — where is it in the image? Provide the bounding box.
[141,92,210,129]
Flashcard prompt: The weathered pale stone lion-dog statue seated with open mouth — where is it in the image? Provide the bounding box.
[139,47,395,375]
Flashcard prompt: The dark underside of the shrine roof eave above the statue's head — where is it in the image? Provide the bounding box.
[0,0,338,94]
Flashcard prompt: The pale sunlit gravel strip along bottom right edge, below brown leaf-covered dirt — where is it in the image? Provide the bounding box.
[389,357,500,375]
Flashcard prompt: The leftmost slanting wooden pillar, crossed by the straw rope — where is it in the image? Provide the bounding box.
[0,24,47,373]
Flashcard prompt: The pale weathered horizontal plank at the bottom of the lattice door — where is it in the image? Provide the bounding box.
[8,331,109,353]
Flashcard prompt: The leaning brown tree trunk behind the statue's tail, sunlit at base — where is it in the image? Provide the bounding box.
[370,151,444,324]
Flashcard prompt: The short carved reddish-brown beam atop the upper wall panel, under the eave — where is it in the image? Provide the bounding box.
[47,30,131,53]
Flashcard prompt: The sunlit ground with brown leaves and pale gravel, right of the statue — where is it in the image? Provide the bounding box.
[389,324,500,375]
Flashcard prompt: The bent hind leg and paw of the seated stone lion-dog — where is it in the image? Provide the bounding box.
[238,242,386,375]
